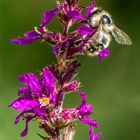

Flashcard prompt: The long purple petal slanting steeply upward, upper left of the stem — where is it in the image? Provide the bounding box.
[40,8,58,32]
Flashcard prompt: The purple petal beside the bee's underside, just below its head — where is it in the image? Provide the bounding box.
[78,24,95,36]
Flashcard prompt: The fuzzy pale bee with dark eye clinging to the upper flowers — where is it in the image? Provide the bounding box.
[85,7,132,56]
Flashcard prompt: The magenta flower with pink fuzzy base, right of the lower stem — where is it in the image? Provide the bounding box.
[59,92,101,140]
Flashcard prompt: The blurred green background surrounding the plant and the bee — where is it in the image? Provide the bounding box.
[0,0,140,140]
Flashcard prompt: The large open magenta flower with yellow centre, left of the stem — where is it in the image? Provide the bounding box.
[9,68,57,136]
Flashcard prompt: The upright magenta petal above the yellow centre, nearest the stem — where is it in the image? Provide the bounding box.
[41,67,55,96]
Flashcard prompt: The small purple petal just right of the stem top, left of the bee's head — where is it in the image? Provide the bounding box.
[68,11,84,20]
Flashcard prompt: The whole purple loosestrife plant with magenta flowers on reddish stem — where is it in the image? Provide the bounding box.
[9,0,131,140]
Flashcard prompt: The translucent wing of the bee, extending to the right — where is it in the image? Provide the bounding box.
[112,26,132,45]
